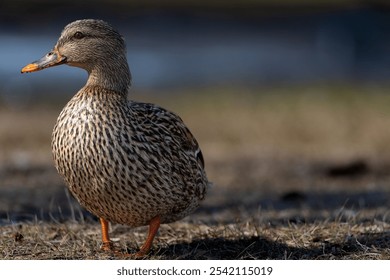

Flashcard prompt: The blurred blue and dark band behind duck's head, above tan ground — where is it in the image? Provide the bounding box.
[0,0,390,98]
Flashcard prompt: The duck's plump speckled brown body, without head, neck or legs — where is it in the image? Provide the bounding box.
[52,87,208,226]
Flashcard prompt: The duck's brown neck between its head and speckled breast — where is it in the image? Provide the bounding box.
[86,57,131,96]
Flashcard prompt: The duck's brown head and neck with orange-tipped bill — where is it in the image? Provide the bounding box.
[21,19,131,93]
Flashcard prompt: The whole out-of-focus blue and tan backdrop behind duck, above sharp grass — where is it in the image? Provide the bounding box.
[0,0,390,225]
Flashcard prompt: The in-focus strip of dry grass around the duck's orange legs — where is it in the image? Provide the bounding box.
[0,220,390,260]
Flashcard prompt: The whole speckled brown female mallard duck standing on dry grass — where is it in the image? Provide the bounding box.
[22,19,209,256]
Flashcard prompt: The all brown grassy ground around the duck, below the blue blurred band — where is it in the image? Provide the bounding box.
[0,85,390,259]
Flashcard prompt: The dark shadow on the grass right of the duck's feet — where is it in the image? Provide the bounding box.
[152,231,390,260]
